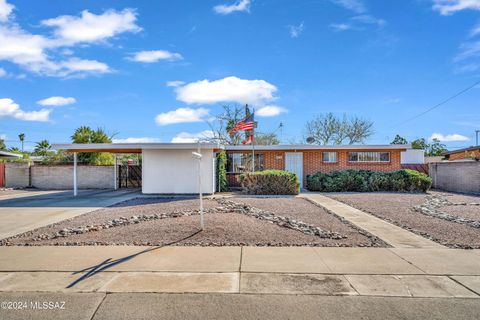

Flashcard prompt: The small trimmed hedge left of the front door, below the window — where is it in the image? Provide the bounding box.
[239,170,300,195]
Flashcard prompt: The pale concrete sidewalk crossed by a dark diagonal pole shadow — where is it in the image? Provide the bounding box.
[0,246,480,298]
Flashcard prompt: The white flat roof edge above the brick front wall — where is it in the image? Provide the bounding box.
[225,144,412,151]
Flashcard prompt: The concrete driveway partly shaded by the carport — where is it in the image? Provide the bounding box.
[0,189,140,239]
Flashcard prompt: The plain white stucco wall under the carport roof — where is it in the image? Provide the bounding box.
[142,149,214,194]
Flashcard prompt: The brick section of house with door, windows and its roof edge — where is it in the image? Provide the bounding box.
[225,144,410,186]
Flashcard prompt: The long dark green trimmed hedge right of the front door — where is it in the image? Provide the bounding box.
[307,169,432,192]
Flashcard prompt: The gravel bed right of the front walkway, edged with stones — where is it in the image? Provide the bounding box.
[326,191,480,249]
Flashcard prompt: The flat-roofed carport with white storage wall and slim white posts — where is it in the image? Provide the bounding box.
[53,143,221,196]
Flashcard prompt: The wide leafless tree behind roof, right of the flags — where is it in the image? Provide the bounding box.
[305,112,374,145]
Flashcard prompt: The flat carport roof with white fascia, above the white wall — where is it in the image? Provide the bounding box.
[52,143,222,153]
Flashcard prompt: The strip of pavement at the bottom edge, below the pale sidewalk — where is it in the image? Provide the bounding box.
[0,292,480,320]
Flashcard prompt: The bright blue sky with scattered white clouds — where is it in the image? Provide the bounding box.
[0,0,480,148]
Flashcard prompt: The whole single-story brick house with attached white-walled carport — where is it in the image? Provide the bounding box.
[53,143,416,194]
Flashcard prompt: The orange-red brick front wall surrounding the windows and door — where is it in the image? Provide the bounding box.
[227,149,402,187]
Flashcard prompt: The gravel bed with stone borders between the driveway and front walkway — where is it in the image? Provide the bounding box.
[0,197,386,247]
